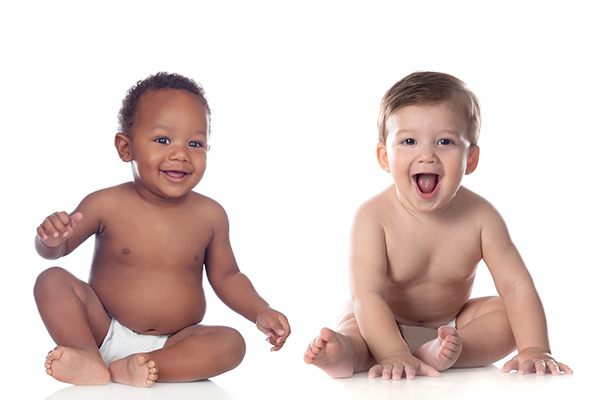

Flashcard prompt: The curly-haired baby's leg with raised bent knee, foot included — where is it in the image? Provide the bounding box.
[34,268,110,385]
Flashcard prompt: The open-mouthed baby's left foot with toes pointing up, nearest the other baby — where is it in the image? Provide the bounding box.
[304,328,354,378]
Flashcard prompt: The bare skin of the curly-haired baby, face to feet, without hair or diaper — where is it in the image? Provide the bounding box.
[34,89,290,386]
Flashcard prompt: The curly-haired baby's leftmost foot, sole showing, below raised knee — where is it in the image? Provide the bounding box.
[44,346,110,385]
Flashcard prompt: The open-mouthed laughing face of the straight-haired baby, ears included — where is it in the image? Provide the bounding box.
[377,101,479,213]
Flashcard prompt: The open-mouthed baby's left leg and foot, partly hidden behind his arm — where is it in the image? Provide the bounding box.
[304,302,375,378]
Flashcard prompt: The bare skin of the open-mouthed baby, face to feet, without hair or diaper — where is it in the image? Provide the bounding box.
[305,101,572,379]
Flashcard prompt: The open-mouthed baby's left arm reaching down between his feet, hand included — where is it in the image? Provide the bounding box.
[350,206,439,379]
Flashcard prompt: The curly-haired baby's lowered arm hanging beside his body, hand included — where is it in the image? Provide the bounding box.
[205,204,291,351]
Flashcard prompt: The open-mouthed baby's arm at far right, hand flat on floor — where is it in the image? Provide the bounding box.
[481,203,572,375]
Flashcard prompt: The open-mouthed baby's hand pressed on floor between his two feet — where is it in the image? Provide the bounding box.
[369,351,440,380]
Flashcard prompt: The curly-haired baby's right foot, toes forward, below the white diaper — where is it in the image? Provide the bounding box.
[108,354,158,387]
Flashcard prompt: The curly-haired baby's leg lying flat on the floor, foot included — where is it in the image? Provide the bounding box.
[109,325,246,386]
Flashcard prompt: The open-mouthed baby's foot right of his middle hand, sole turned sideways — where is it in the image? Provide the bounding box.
[413,326,462,371]
